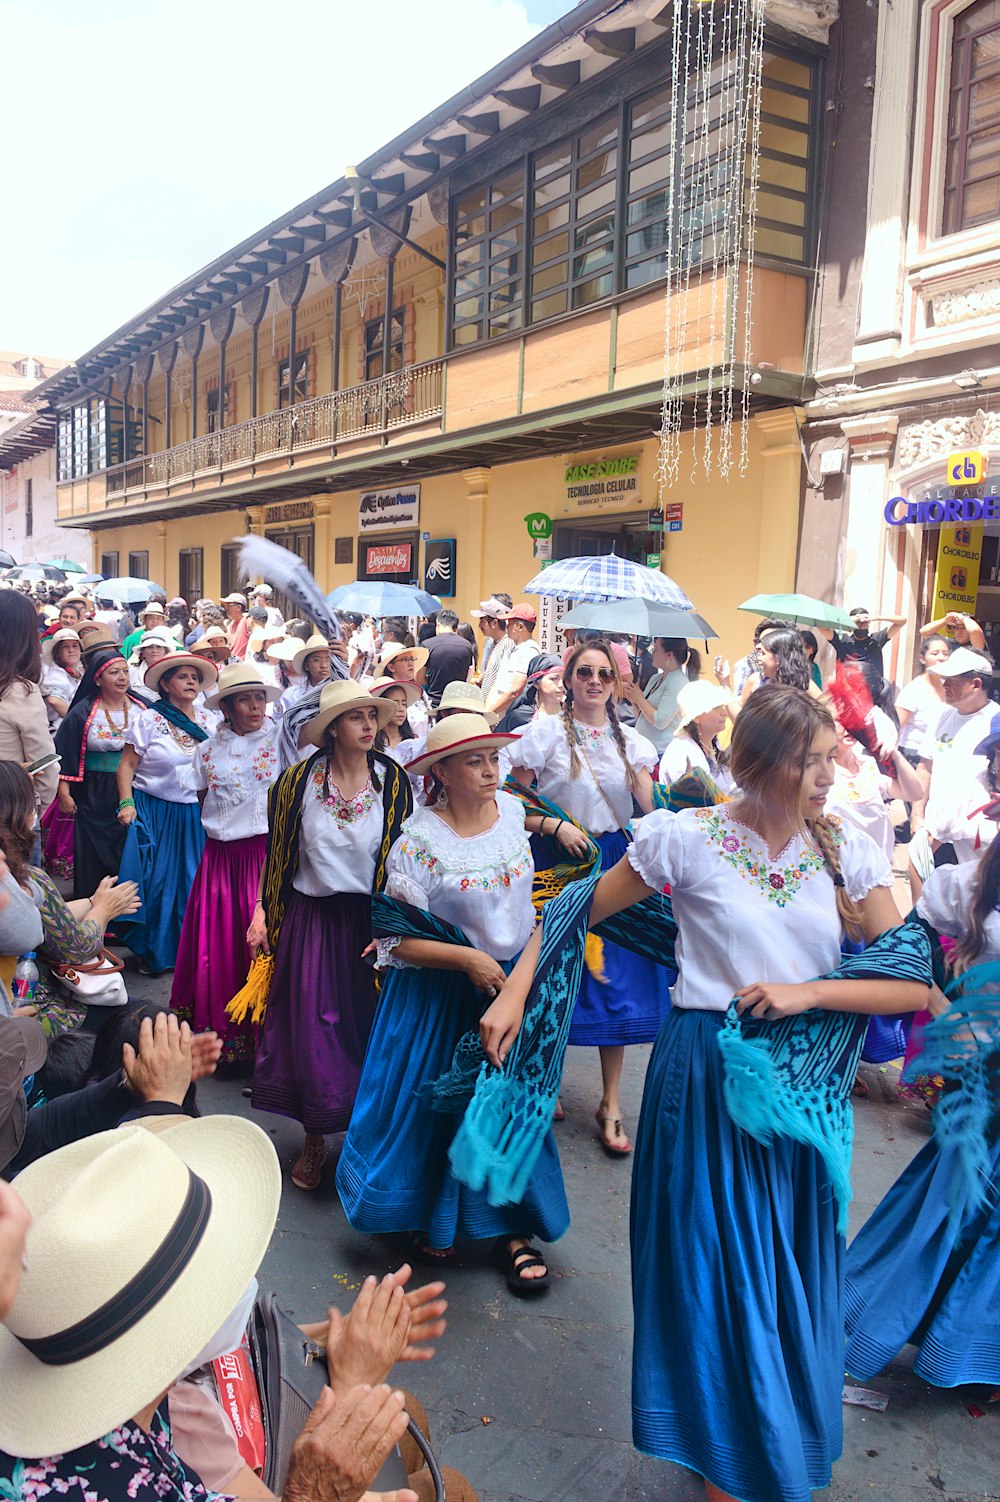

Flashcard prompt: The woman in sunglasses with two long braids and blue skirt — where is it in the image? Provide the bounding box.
[512,641,670,1157]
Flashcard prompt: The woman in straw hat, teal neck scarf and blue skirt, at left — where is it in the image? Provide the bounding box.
[119,652,219,975]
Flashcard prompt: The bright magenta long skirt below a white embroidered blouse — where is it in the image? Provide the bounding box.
[170,835,267,1063]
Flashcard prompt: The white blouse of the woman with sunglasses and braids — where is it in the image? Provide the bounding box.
[511,715,659,835]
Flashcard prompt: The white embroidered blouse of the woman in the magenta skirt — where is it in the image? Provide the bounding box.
[182,724,281,840]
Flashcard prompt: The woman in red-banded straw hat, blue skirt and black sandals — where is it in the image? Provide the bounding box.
[336,713,569,1293]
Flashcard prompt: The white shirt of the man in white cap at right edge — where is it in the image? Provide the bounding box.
[923,700,1000,861]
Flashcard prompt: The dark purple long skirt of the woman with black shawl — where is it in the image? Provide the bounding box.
[251,891,375,1137]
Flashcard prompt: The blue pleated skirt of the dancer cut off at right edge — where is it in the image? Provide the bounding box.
[845,1142,1000,1388]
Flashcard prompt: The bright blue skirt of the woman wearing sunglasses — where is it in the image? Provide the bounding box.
[569,829,677,1047]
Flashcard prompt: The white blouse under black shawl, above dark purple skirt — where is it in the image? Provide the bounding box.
[291,769,383,897]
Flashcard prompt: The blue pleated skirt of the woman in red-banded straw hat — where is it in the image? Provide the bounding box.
[336,969,569,1247]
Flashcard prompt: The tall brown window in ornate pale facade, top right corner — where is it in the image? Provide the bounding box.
[943,0,1000,234]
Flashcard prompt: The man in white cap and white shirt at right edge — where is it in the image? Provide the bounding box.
[922,647,997,862]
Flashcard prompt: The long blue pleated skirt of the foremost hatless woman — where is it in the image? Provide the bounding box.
[632,1011,844,1502]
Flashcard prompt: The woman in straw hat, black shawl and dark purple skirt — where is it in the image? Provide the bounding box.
[248,679,413,1190]
